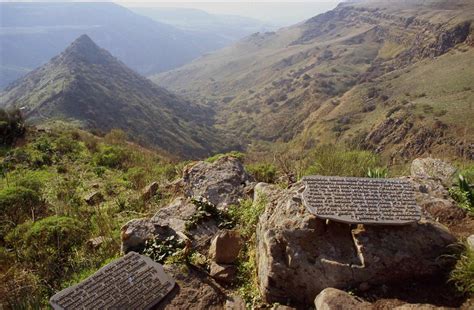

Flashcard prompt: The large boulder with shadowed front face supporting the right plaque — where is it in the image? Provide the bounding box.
[256,184,456,305]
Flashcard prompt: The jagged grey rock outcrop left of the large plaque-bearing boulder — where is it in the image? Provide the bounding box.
[121,156,252,253]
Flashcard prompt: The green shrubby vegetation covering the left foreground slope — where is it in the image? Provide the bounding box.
[0,123,177,308]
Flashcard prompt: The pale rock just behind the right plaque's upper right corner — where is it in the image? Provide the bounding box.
[411,158,456,185]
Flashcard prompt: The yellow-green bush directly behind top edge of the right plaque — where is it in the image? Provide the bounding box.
[304,145,380,177]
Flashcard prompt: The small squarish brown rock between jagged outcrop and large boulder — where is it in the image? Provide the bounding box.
[209,230,242,264]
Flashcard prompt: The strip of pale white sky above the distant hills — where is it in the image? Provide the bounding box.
[119,0,342,27]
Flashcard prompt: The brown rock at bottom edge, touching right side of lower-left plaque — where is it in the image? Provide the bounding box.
[154,265,227,310]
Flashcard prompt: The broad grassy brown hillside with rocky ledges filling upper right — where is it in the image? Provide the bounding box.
[153,0,474,160]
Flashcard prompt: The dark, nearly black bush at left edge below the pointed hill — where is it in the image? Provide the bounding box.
[0,109,26,146]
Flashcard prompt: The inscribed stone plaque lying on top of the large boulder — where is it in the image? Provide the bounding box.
[303,176,421,225]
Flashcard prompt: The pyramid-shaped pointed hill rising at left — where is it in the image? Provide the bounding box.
[0,35,222,157]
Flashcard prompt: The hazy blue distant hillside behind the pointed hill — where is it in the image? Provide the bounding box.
[0,2,232,88]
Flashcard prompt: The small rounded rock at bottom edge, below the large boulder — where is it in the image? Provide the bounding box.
[314,288,371,310]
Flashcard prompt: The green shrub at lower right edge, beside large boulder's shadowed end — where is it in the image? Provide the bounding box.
[450,246,474,295]
